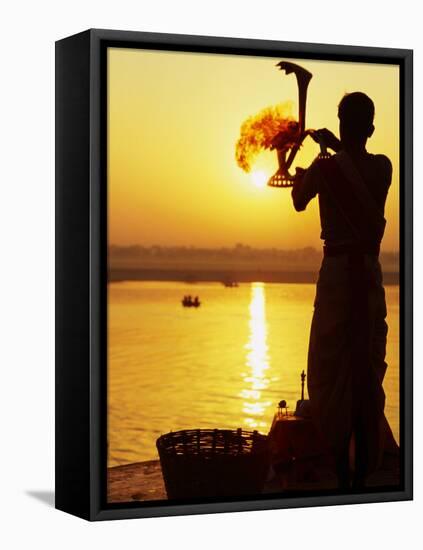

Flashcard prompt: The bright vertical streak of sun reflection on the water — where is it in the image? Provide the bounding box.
[240,283,271,429]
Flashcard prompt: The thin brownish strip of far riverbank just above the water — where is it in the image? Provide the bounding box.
[109,268,399,285]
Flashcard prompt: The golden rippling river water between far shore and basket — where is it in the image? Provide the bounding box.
[108,281,399,466]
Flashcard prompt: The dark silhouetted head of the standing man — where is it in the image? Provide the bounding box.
[338,92,375,146]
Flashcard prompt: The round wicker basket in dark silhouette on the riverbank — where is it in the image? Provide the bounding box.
[156,428,269,499]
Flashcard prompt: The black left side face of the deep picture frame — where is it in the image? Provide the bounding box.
[55,32,91,519]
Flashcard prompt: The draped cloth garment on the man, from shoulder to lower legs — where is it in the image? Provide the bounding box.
[308,152,389,473]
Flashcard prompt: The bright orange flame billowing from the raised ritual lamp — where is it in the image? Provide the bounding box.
[235,102,298,172]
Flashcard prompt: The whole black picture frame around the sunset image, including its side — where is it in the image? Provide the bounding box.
[55,29,413,520]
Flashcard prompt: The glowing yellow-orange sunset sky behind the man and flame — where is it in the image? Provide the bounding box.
[108,48,399,250]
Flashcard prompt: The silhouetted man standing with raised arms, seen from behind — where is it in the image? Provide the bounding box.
[292,92,392,488]
